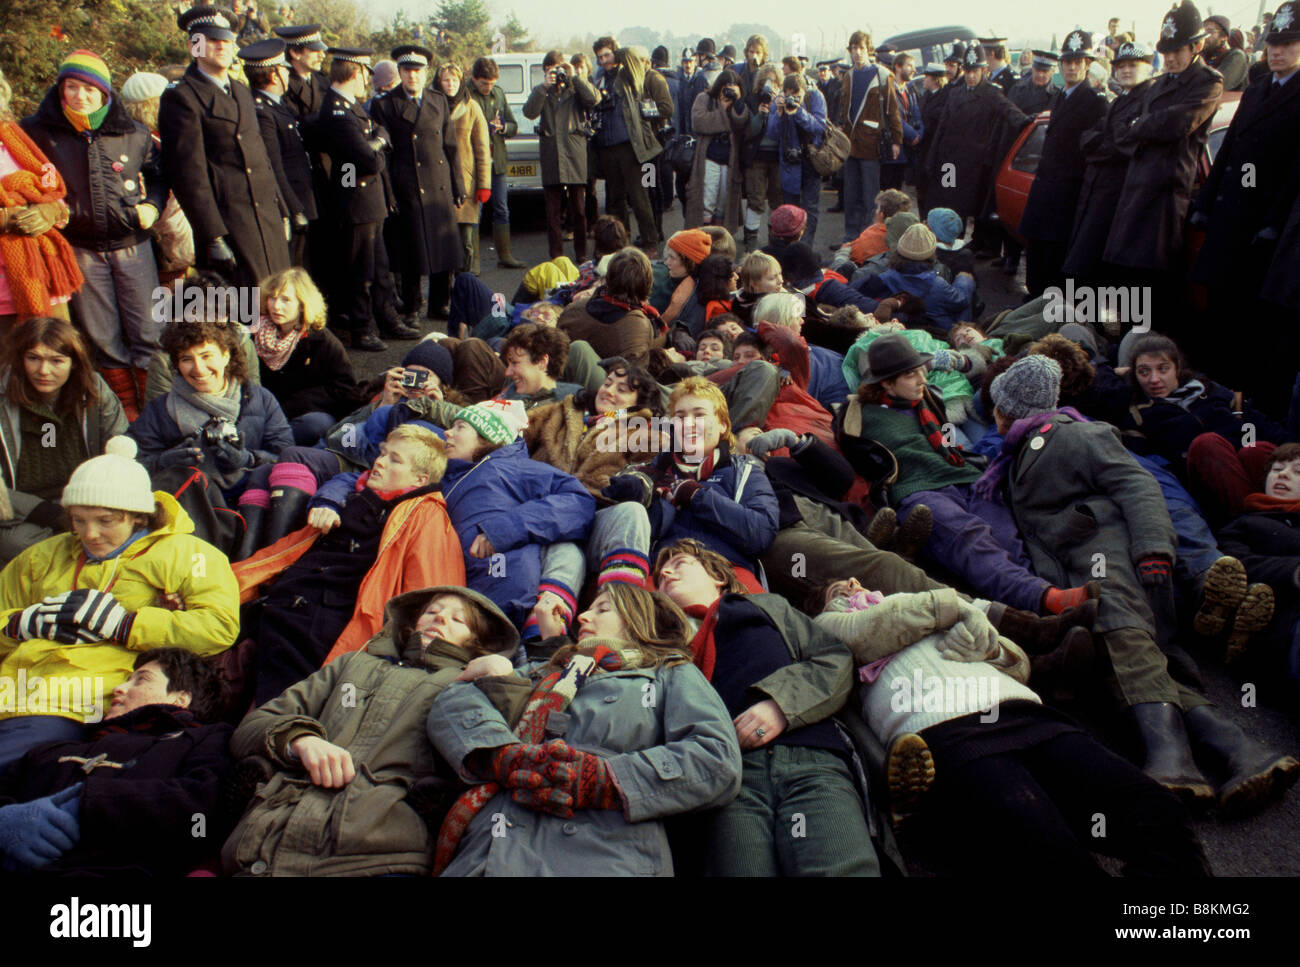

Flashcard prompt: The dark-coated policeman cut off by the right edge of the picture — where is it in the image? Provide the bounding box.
[1192,0,1300,416]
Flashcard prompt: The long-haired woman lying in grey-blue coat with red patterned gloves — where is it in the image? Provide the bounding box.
[429,584,740,876]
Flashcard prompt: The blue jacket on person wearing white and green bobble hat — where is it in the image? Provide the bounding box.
[442,439,595,625]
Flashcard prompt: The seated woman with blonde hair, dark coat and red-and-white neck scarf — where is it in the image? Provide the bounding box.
[252,266,365,446]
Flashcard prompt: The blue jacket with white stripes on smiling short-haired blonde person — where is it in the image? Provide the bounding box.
[631,443,780,574]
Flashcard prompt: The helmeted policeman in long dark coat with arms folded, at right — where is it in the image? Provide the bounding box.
[1104,0,1223,339]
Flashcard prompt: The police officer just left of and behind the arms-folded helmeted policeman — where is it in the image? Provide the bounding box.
[1063,43,1156,285]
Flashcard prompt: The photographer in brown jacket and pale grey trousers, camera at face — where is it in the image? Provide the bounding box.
[685,70,749,233]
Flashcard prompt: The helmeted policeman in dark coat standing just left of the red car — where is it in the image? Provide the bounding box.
[926,45,1032,255]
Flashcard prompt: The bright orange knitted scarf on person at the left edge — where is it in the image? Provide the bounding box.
[0,122,85,322]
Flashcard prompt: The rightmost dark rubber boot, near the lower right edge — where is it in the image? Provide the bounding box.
[1183,706,1300,816]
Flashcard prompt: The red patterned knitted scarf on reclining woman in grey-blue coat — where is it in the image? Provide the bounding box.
[433,645,623,876]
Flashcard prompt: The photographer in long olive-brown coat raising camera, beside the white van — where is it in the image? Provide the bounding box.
[524,51,601,265]
